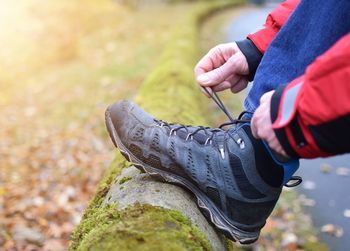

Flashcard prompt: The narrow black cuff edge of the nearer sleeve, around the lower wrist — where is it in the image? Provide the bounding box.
[270,84,299,159]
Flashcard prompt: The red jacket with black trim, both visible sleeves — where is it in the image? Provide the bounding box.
[248,0,350,158]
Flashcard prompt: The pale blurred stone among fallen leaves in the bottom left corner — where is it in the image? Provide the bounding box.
[12,225,44,246]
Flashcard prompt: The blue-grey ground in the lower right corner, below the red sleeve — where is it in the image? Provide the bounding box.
[297,158,350,250]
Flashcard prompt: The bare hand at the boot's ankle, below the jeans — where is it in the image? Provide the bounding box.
[251,91,288,157]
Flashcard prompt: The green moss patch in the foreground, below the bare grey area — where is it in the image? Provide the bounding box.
[77,204,211,250]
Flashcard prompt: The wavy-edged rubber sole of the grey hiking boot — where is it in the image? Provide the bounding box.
[105,109,259,244]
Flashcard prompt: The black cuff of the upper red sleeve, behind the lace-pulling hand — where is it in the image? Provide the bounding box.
[236,39,263,81]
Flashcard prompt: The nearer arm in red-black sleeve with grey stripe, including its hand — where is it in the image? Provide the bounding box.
[252,33,350,158]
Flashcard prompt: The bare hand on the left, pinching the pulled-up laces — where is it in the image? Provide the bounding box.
[194,43,249,95]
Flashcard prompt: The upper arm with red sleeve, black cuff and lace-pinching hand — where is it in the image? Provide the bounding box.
[195,0,299,93]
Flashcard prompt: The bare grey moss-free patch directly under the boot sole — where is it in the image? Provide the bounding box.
[102,166,226,251]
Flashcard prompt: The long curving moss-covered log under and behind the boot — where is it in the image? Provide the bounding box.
[70,0,243,250]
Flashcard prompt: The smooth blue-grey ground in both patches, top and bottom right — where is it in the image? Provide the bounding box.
[226,3,350,251]
